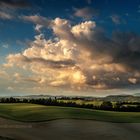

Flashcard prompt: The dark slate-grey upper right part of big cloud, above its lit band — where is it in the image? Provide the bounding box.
[77,31,140,71]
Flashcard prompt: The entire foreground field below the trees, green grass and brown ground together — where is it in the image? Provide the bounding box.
[0,104,140,140]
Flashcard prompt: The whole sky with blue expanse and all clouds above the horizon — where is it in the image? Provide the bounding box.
[0,0,140,96]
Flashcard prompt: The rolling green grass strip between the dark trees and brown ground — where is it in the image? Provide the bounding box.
[0,104,140,122]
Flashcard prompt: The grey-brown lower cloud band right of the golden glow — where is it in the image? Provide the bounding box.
[86,71,140,89]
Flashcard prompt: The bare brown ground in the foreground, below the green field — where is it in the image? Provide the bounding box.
[0,118,140,140]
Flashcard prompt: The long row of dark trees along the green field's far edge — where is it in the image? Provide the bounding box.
[0,97,140,112]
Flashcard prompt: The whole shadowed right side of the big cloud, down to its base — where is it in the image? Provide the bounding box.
[77,32,140,89]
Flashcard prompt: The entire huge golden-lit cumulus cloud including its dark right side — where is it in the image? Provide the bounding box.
[5,17,140,90]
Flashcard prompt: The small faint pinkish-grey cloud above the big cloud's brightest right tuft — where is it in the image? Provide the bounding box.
[74,7,98,19]
